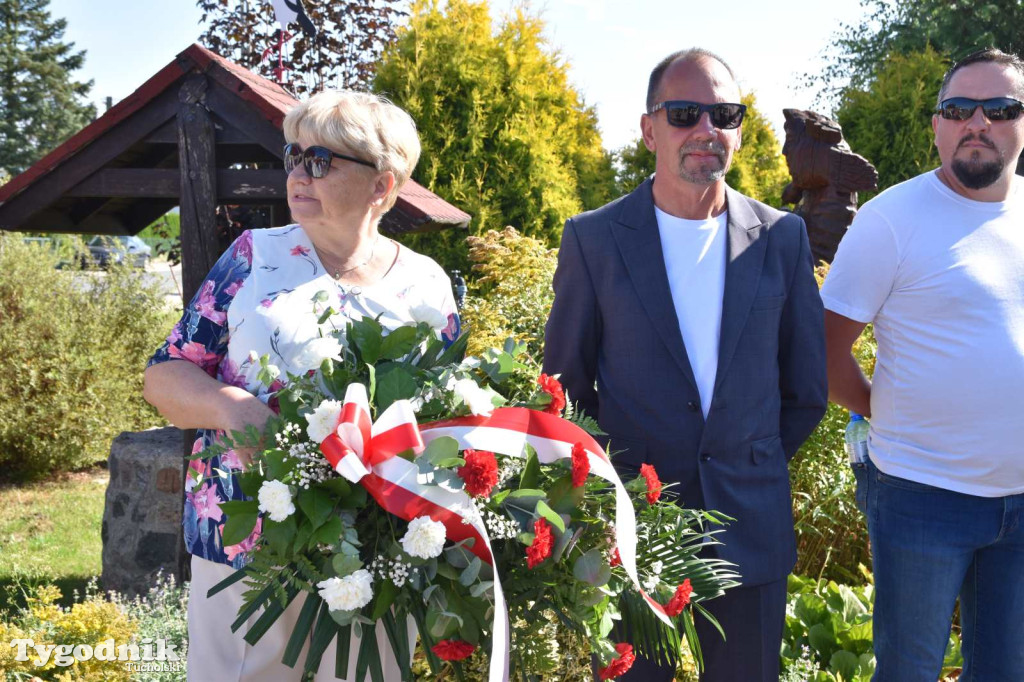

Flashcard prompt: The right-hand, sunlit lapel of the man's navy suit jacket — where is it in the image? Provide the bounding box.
[715,187,768,393]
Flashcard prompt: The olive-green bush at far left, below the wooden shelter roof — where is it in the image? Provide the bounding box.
[0,235,175,480]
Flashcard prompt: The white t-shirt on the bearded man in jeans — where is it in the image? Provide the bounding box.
[821,172,1024,497]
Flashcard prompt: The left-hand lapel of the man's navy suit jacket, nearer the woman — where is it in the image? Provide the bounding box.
[611,179,697,390]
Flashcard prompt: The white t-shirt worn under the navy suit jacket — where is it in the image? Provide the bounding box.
[654,206,728,418]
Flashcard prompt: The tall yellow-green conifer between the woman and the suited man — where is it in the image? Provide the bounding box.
[374,0,614,269]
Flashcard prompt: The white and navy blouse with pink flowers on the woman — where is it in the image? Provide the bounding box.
[148,225,460,568]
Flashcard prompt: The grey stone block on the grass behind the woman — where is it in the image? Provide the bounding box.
[100,427,184,596]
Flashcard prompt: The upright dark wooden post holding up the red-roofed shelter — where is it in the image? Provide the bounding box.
[176,74,220,582]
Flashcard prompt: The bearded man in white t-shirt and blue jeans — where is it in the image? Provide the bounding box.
[821,49,1024,682]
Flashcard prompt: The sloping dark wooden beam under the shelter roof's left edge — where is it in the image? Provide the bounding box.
[0,88,177,229]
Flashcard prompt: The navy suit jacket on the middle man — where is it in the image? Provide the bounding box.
[544,179,827,586]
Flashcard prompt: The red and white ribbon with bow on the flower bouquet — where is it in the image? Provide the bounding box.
[321,384,674,682]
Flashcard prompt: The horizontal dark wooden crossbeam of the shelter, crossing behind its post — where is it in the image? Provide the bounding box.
[67,168,287,199]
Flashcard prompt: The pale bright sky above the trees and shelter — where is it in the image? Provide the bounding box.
[50,0,863,150]
